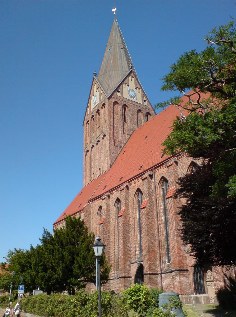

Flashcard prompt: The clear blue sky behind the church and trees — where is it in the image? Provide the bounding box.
[0,0,236,262]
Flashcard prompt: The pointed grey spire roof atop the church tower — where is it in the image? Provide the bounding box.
[97,19,133,96]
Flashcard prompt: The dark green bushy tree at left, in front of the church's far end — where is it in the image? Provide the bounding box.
[0,217,110,293]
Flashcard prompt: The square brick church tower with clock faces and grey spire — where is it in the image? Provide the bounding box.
[84,19,155,185]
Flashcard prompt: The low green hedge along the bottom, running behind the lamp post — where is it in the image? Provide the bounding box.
[16,284,183,317]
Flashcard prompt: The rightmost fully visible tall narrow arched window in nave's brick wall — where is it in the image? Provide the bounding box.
[160,178,171,263]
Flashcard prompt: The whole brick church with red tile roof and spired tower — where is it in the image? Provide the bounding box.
[54,19,225,299]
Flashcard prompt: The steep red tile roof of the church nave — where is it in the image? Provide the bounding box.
[55,106,183,224]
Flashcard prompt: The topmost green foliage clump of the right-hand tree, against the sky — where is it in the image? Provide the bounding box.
[162,21,236,99]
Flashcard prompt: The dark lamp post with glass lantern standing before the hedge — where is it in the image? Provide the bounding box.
[93,237,105,317]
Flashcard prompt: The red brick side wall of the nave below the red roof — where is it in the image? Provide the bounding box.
[84,156,204,294]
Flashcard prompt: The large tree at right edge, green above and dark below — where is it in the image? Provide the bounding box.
[159,21,236,265]
